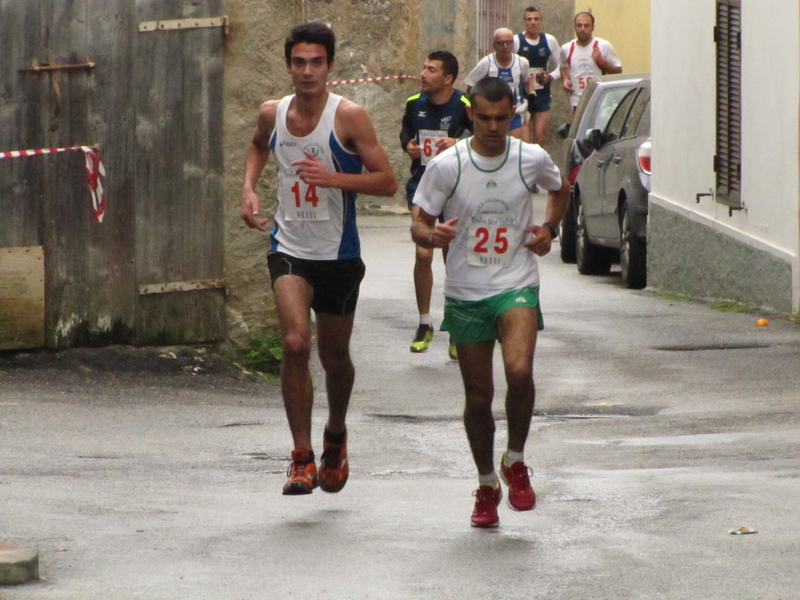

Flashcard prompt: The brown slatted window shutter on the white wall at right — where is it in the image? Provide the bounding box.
[714,0,742,210]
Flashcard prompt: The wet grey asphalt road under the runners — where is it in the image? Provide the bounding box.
[0,215,800,600]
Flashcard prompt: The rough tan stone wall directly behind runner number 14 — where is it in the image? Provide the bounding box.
[224,0,419,345]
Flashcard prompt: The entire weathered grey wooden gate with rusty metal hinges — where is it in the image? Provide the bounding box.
[0,0,225,348]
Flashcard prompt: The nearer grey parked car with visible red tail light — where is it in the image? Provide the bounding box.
[573,78,650,289]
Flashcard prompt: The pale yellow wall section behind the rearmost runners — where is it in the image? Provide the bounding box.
[573,0,650,73]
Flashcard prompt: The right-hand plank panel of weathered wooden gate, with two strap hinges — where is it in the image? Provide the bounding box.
[133,0,225,344]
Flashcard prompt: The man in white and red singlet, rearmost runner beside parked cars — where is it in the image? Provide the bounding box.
[561,12,622,111]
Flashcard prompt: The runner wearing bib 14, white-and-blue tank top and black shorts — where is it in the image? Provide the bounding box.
[241,23,397,495]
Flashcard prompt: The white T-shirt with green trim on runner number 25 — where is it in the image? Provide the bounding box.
[414,137,561,301]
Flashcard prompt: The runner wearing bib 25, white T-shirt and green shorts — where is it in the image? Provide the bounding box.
[411,77,569,527]
